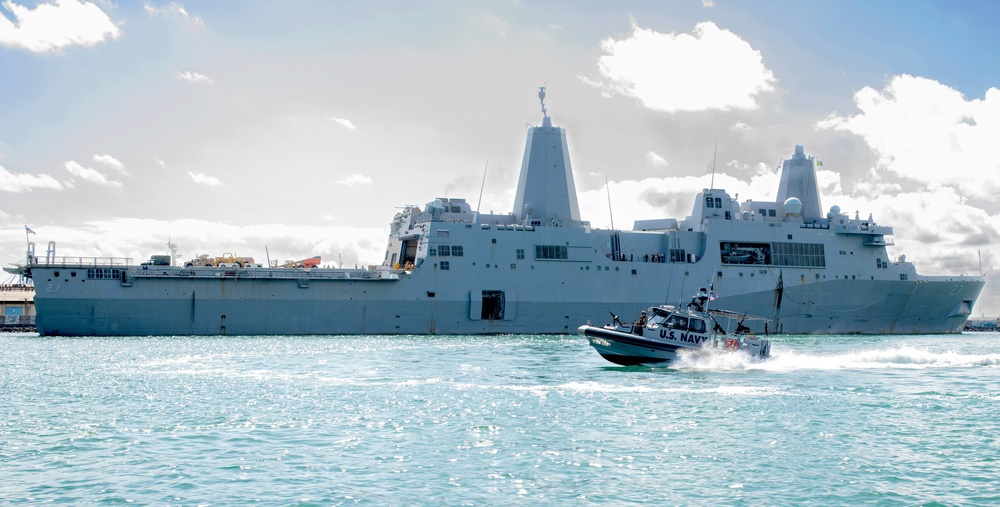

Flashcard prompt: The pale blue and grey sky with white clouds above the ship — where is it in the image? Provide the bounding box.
[0,0,1000,318]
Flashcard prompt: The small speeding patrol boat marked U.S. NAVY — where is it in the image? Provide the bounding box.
[577,298,771,366]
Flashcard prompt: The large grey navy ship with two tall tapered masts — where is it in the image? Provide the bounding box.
[6,87,985,336]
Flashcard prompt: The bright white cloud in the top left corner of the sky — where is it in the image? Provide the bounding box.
[0,0,122,53]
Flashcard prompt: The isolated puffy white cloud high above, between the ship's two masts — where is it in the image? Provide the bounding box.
[584,21,777,112]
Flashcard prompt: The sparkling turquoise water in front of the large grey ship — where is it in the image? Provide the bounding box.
[0,333,1000,506]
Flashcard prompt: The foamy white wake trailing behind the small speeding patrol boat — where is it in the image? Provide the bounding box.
[671,345,1000,371]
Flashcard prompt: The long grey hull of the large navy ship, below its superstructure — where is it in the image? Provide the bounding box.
[32,262,983,336]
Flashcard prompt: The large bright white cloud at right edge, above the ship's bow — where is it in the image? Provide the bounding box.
[817,75,1000,198]
